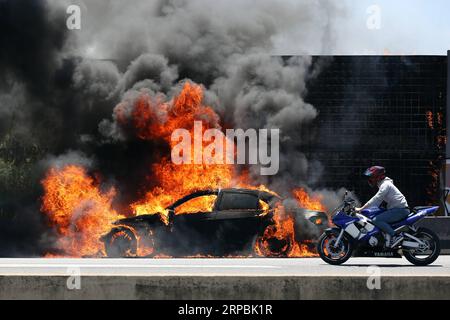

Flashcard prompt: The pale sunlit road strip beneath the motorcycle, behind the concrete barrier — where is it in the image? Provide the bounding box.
[0,256,450,277]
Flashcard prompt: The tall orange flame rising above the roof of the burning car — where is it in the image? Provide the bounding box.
[122,82,236,221]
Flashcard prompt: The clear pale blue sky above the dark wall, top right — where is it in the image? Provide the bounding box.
[335,0,450,55]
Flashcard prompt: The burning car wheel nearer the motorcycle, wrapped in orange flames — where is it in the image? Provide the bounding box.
[254,225,294,257]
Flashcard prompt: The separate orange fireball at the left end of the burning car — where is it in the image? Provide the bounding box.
[41,165,122,257]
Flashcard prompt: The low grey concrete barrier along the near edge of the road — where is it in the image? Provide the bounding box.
[0,276,450,300]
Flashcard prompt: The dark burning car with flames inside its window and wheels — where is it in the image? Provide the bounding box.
[101,189,328,257]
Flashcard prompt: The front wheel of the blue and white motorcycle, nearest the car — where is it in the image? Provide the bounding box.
[317,232,353,265]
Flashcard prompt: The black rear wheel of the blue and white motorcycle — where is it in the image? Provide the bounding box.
[403,228,441,266]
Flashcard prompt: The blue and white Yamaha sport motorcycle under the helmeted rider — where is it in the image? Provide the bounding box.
[317,192,441,266]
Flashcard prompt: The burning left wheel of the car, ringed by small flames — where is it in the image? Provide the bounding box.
[104,227,137,258]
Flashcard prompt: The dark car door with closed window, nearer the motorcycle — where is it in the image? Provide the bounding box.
[214,191,262,251]
